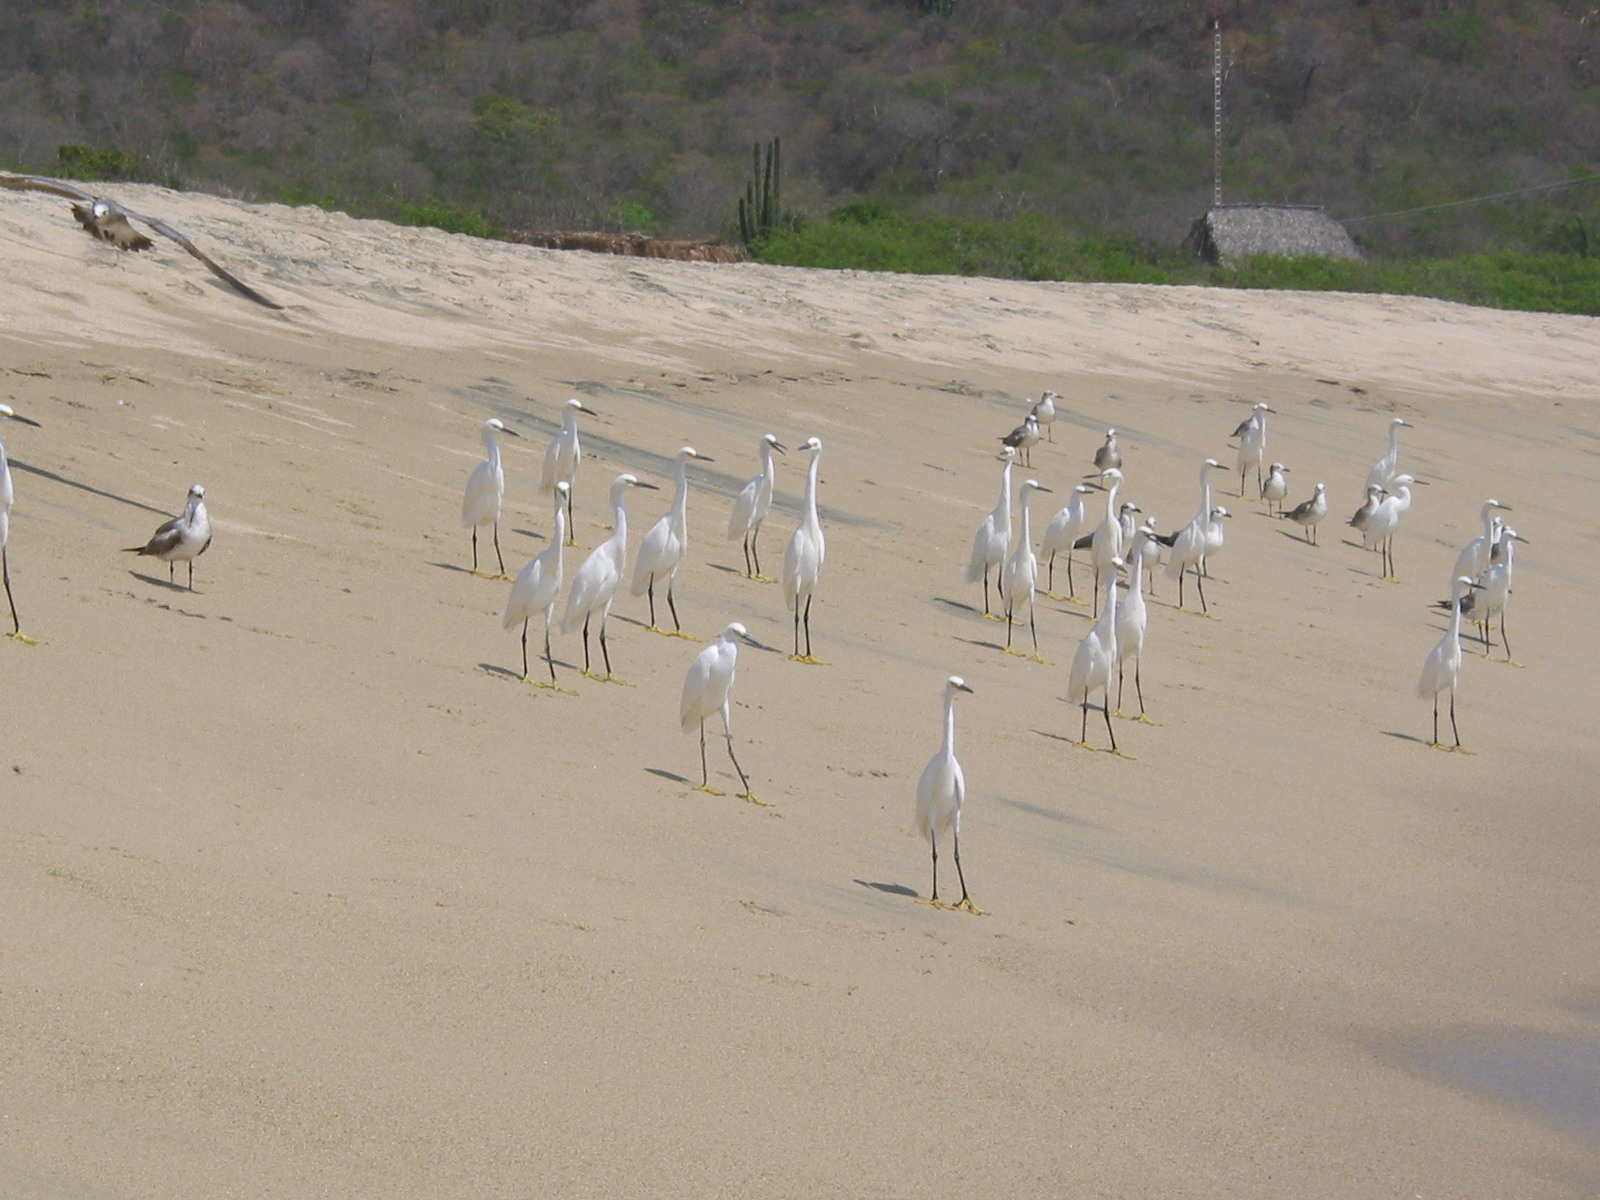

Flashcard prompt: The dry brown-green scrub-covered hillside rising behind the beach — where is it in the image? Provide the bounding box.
[0,0,1600,277]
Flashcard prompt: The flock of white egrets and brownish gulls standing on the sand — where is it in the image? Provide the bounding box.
[0,392,1526,912]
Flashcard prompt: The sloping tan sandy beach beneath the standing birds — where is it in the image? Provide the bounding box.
[0,186,1600,1200]
